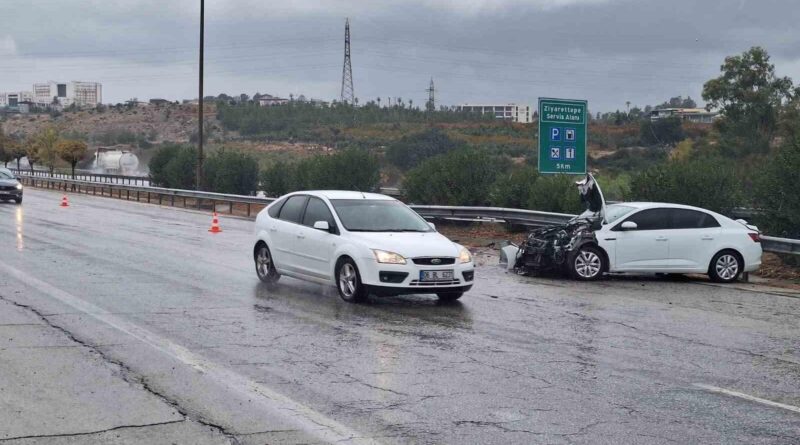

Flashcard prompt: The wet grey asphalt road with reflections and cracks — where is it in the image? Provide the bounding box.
[0,189,800,444]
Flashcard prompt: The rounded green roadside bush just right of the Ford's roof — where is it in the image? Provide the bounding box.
[403,149,510,205]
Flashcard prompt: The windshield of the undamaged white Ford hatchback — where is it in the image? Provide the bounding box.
[331,199,432,232]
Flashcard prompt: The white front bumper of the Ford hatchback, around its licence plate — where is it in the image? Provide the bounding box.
[359,258,475,294]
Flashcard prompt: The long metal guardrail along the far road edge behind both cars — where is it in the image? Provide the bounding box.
[15,173,800,255]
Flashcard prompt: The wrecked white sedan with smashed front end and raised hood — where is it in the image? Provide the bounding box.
[501,175,762,283]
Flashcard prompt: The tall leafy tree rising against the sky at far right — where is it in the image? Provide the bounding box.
[703,46,798,156]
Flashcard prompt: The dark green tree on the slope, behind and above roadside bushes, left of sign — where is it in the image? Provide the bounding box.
[386,127,463,169]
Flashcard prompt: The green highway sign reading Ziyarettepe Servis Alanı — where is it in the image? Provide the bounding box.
[539,97,588,175]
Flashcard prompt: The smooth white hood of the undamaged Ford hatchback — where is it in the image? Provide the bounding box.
[350,232,459,258]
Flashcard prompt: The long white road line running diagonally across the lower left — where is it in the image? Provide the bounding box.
[0,261,379,445]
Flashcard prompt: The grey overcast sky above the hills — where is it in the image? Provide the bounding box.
[0,0,800,111]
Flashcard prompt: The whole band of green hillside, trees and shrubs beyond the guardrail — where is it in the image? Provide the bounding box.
[0,47,800,237]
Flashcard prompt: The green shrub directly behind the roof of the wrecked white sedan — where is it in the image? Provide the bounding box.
[631,158,742,213]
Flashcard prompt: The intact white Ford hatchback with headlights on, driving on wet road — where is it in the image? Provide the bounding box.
[253,191,475,302]
